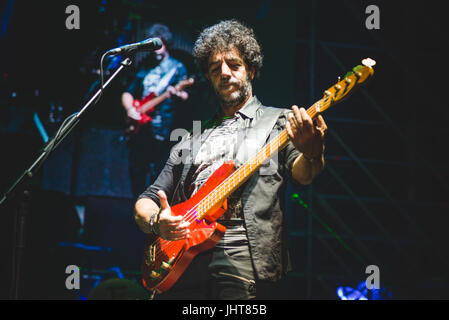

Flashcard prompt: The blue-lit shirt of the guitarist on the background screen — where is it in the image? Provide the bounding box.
[126,56,187,141]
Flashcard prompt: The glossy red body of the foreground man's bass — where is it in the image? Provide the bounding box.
[142,161,235,293]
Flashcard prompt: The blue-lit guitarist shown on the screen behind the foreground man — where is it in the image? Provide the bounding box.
[122,24,189,197]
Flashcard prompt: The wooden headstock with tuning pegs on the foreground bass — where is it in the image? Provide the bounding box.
[319,58,376,112]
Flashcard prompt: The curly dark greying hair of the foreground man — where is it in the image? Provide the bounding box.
[193,19,263,77]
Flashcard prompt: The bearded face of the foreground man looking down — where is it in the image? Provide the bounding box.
[207,48,254,107]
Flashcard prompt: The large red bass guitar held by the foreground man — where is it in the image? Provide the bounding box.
[142,58,375,293]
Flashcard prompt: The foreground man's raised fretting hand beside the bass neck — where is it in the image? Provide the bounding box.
[286,106,327,159]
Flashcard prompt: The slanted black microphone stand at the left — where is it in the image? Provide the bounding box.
[0,57,132,300]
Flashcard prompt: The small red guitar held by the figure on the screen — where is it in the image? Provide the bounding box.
[125,77,195,135]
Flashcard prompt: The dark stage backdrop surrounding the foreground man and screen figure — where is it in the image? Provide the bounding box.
[0,0,449,299]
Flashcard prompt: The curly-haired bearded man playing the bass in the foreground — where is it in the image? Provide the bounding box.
[135,20,327,299]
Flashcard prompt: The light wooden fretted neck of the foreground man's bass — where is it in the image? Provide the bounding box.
[197,99,324,220]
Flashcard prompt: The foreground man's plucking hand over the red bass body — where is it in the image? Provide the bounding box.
[157,190,190,241]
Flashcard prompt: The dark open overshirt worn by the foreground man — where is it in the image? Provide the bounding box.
[139,97,300,281]
